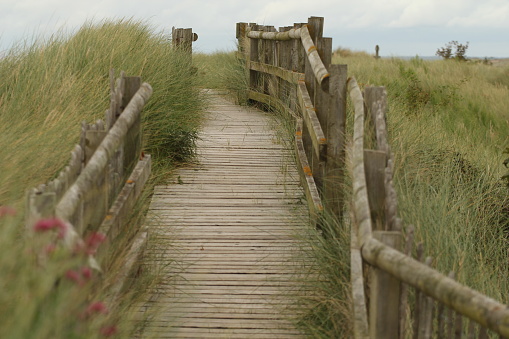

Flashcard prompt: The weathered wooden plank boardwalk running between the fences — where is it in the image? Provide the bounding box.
[141,93,309,338]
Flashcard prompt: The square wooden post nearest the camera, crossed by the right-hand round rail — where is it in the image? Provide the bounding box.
[369,231,401,339]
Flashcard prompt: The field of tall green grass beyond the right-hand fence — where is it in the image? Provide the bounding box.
[335,56,509,303]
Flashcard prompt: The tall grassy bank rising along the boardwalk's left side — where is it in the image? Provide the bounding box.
[0,20,203,338]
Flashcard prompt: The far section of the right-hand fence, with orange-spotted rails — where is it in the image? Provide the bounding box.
[237,17,346,223]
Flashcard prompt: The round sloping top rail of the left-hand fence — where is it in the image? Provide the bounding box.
[55,83,152,226]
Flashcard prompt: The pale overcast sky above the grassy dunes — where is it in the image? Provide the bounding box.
[0,0,509,57]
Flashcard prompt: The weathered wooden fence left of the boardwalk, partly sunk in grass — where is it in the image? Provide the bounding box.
[26,71,152,290]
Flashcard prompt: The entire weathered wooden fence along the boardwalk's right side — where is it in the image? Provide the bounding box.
[237,17,509,338]
